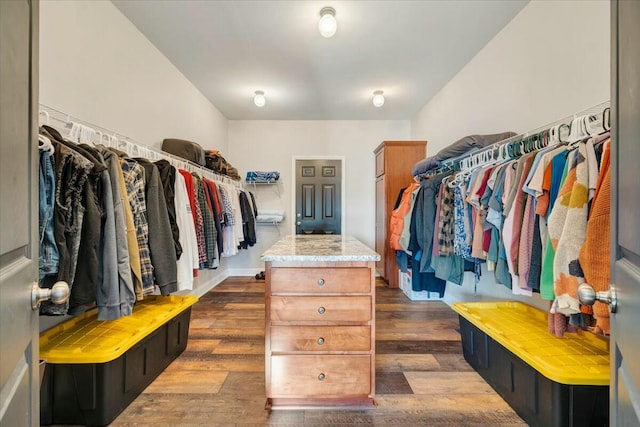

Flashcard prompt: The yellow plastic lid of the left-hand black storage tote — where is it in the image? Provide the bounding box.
[40,295,198,364]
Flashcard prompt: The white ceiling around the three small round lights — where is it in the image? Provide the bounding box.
[113,0,528,120]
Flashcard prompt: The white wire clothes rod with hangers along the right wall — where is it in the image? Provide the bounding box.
[416,101,611,178]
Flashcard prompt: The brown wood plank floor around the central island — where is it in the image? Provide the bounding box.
[112,277,526,427]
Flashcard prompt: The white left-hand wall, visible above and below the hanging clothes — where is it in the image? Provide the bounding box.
[40,0,228,294]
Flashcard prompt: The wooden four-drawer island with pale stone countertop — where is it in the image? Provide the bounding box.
[262,235,380,408]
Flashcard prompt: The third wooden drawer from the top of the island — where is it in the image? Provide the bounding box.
[271,326,371,352]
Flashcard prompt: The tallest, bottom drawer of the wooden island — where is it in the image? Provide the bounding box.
[267,355,371,398]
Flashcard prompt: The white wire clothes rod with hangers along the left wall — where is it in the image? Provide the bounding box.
[39,104,243,189]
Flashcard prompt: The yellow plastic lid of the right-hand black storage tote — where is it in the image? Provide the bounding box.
[451,301,610,386]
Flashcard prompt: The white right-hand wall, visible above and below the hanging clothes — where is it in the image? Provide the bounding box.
[411,0,610,308]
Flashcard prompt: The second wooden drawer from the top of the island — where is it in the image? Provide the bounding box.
[270,296,371,322]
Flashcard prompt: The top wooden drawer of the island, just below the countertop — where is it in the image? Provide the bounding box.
[271,267,371,294]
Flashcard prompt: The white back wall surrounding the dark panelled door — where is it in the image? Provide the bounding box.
[228,120,410,274]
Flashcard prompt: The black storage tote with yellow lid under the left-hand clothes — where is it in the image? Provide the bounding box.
[40,296,198,425]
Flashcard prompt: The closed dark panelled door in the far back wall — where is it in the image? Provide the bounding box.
[296,160,342,234]
